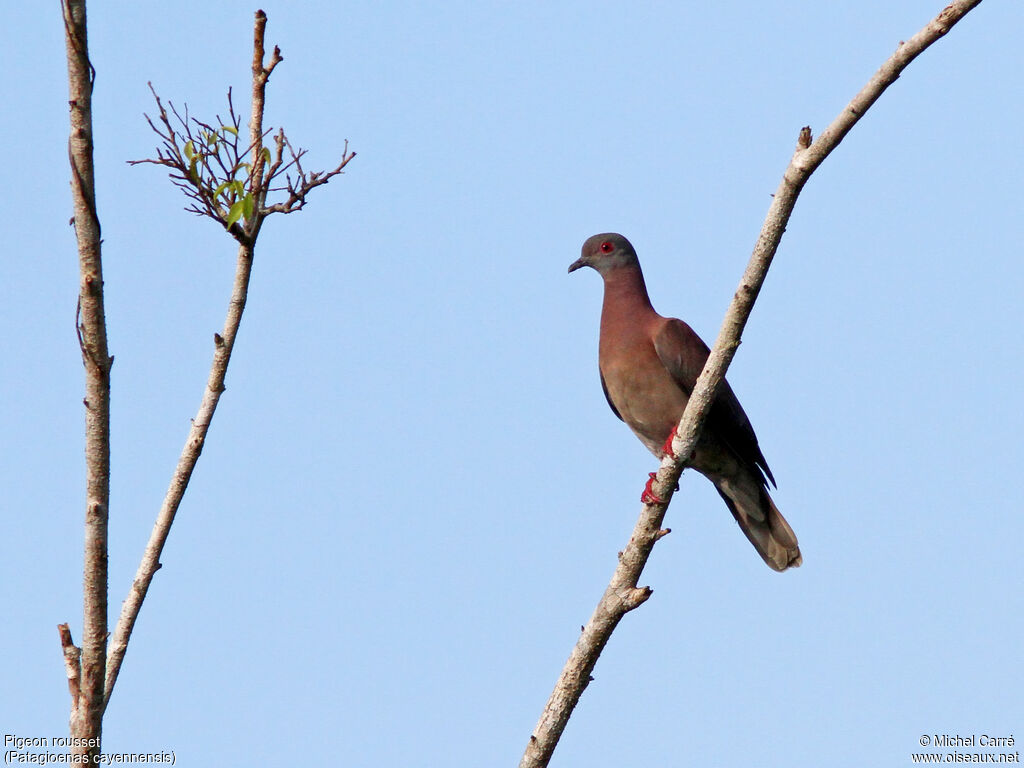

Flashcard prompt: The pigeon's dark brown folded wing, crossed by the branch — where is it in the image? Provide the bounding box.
[655,318,775,485]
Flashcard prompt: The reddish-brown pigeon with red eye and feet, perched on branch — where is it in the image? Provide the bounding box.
[569,232,802,571]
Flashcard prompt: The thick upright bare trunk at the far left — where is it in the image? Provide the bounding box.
[60,0,114,759]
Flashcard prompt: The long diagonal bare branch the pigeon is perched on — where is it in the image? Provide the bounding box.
[519,0,981,768]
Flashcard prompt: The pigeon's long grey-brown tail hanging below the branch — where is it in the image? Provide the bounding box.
[715,480,804,570]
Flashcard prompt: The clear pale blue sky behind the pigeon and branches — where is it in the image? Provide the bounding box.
[0,0,1024,768]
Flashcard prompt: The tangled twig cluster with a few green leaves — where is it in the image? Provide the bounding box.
[129,83,355,243]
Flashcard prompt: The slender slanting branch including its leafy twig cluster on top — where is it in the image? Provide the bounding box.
[103,10,355,707]
